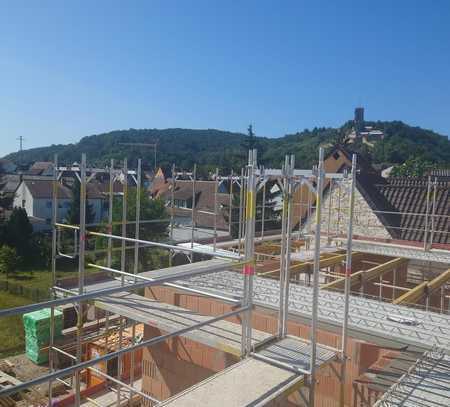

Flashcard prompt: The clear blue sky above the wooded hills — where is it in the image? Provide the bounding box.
[0,0,450,156]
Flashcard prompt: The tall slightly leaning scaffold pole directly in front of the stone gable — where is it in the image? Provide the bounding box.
[339,154,356,407]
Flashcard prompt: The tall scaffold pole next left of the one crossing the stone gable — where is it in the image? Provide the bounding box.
[309,148,324,406]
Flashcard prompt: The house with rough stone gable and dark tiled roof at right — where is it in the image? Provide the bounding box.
[294,147,450,284]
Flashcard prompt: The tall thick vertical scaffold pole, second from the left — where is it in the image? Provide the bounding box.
[75,154,86,406]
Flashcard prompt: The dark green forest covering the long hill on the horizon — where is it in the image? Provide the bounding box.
[4,121,450,173]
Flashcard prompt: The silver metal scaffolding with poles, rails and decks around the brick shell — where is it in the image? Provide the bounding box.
[0,148,450,406]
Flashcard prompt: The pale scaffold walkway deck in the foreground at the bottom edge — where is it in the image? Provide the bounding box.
[160,337,336,407]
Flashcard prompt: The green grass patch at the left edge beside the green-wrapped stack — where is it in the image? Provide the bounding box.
[0,291,31,358]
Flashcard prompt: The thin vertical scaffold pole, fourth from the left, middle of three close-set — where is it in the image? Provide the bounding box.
[117,158,128,407]
